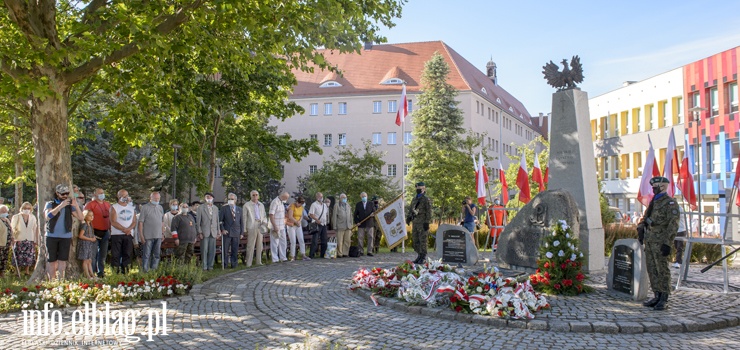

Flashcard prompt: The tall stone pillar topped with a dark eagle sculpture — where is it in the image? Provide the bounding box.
[543,56,605,272]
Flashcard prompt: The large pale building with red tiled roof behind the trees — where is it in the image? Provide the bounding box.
[272,41,546,191]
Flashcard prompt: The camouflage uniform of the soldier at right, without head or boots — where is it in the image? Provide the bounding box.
[645,193,679,295]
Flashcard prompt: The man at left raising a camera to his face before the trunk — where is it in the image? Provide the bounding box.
[44,184,84,280]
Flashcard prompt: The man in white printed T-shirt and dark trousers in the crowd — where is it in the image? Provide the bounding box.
[110,190,137,274]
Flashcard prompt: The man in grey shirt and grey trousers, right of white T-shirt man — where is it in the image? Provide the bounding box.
[139,192,164,272]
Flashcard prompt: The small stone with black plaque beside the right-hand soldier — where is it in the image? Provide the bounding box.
[606,238,649,301]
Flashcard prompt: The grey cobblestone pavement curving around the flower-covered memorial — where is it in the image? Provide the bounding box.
[0,253,740,350]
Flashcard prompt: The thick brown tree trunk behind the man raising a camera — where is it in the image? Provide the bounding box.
[27,87,81,284]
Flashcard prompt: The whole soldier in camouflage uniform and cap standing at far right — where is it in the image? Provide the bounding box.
[637,176,679,310]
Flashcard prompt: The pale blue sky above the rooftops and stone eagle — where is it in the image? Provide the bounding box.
[381,0,740,115]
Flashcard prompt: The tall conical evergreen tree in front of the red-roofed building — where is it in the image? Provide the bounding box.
[406,52,478,219]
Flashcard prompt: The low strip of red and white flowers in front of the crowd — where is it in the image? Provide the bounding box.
[0,276,192,312]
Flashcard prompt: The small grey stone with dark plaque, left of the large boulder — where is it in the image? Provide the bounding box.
[435,224,478,265]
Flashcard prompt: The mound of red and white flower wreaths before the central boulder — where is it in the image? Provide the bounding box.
[349,260,550,319]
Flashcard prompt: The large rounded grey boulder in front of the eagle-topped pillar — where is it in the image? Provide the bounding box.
[496,190,585,272]
